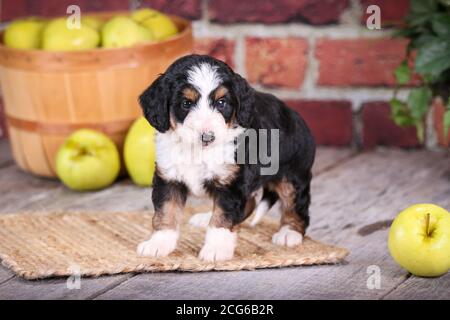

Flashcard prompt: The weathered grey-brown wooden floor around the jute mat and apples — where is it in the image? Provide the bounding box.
[0,140,450,299]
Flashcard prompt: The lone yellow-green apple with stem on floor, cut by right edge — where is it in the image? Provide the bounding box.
[388,204,450,277]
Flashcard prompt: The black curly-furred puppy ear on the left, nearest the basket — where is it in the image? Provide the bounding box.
[139,74,170,133]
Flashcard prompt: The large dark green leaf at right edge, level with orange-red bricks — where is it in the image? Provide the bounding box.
[415,37,450,78]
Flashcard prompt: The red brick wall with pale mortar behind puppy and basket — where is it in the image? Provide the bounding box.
[0,0,445,148]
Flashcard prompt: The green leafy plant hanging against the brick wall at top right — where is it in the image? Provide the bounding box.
[391,0,450,141]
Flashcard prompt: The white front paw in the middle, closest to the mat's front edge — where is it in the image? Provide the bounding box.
[199,228,237,261]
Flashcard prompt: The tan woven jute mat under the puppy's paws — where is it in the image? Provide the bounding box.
[0,208,348,279]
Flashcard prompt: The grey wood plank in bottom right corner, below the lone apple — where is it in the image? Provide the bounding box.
[384,273,450,300]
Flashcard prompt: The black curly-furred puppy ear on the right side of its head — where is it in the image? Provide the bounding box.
[233,73,255,128]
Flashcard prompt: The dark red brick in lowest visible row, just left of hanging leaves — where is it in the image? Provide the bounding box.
[362,102,420,149]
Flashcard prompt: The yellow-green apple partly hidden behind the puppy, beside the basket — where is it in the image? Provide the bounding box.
[123,117,156,186]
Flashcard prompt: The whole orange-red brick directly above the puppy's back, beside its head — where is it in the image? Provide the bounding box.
[245,38,308,88]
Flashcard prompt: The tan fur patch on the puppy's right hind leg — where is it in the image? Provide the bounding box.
[269,179,306,235]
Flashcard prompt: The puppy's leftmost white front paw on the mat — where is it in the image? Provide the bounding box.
[137,230,178,257]
